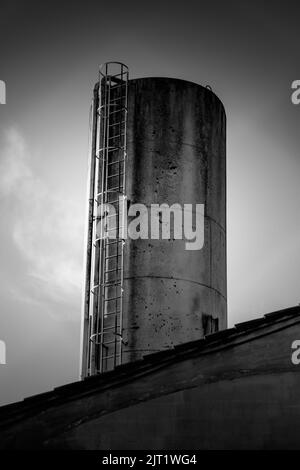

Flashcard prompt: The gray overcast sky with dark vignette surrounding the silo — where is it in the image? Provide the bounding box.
[0,0,300,404]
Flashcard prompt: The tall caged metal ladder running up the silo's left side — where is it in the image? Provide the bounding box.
[86,62,128,375]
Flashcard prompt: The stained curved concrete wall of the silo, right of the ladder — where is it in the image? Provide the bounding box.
[123,78,227,361]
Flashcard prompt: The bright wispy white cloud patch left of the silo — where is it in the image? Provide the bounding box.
[0,128,83,308]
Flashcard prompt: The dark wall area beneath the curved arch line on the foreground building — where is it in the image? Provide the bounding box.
[47,373,300,450]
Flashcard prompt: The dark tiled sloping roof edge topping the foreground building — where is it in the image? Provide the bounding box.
[0,305,300,427]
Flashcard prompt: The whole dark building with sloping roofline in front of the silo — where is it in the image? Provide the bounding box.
[0,307,300,450]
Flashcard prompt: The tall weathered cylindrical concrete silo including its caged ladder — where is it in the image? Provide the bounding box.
[82,64,227,376]
